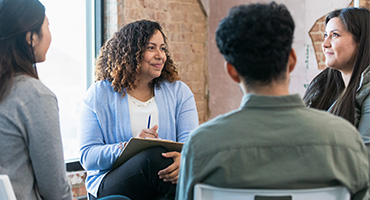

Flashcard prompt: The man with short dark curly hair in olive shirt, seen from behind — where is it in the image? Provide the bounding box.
[176,2,369,200]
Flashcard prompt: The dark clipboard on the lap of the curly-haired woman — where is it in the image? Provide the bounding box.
[112,138,184,169]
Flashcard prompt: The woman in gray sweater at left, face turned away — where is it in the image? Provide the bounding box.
[0,0,72,200]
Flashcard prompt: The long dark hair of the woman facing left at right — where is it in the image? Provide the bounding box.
[304,8,370,124]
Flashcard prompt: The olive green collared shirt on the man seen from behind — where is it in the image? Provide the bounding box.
[176,95,369,200]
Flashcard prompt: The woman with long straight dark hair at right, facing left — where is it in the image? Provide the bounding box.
[304,8,370,144]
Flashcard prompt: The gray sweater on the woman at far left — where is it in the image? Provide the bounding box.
[0,75,72,200]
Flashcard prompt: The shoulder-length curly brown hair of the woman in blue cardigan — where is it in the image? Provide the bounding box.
[95,20,180,96]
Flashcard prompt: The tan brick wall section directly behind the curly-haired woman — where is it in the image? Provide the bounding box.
[105,0,208,123]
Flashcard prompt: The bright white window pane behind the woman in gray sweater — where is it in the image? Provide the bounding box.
[37,0,86,160]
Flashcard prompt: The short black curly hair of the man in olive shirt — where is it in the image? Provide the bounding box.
[216,2,294,85]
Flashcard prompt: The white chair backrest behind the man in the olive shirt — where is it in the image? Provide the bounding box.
[194,184,350,200]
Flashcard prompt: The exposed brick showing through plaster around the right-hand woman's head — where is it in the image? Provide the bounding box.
[309,0,370,70]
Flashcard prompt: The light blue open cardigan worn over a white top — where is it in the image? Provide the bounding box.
[79,81,199,196]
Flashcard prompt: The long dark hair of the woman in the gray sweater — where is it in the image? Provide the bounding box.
[0,0,45,102]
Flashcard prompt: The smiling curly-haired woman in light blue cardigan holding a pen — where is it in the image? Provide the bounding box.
[80,20,198,199]
